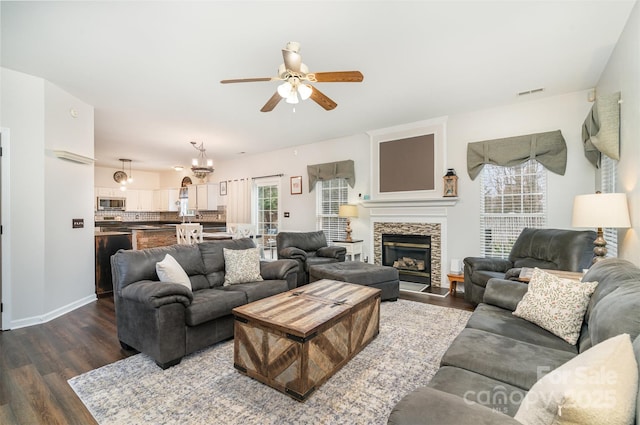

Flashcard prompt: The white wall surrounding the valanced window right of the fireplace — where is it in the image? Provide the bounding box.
[447,91,595,258]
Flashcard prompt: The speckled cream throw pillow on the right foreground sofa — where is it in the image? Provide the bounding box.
[513,268,598,345]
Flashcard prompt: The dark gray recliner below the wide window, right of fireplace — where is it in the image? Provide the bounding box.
[464,228,596,304]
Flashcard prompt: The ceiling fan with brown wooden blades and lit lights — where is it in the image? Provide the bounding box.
[220,41,364,112]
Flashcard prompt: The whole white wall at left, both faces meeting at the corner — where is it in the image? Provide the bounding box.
[0,68,95,328]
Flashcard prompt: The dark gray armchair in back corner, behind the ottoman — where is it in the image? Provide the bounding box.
[276,230,347,286]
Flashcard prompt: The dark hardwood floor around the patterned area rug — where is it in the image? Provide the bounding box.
[0,292,473,425]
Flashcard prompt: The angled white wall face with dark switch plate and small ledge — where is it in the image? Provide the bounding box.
[41,82,95,315]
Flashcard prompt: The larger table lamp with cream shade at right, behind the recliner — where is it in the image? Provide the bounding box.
[572,192,631,263]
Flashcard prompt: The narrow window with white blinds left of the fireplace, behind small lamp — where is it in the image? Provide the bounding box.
[316,178,349,243]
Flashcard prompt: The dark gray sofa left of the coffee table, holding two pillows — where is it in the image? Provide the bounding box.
[111,239,298,369]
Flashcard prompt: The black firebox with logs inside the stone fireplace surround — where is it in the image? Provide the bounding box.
[382,233,431,285]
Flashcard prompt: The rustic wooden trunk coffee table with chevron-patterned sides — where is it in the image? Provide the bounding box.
[233,279,381,401]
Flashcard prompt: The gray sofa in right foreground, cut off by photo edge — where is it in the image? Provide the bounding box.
[388,259,640,425]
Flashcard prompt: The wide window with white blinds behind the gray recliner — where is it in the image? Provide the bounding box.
[480,160,547,258]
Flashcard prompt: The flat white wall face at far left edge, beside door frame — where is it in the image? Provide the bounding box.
[0,68,46,322]
